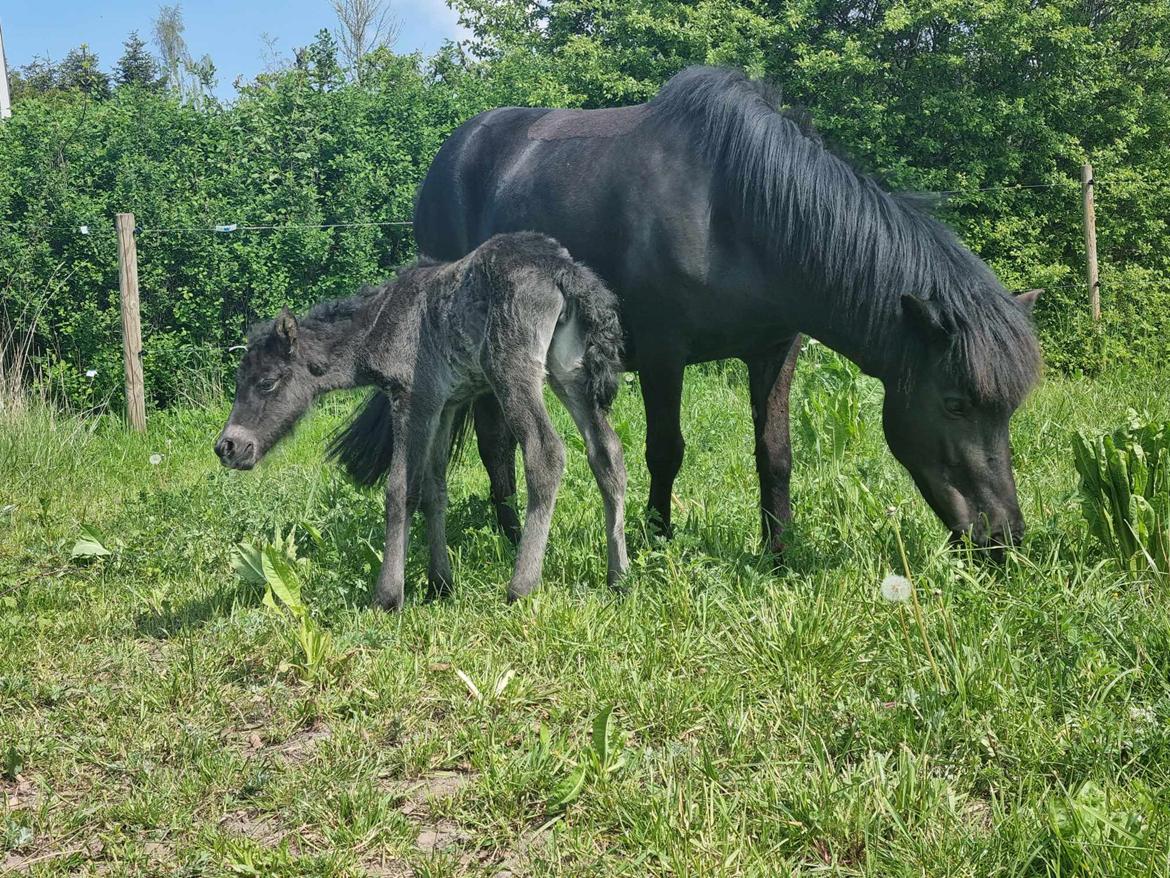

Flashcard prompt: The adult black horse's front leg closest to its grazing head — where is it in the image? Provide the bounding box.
[744,335,801,555]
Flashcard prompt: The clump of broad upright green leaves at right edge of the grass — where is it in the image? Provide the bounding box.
[1073,413,1170,576]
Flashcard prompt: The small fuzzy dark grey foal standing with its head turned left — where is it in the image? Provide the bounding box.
[215,233,628,610]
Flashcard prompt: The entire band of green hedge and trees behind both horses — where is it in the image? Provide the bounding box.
[0,0,1170,405]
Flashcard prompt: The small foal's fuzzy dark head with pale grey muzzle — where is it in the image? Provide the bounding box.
[215,308,322,469]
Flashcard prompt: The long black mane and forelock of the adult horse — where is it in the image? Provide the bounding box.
[651,67,1040,406]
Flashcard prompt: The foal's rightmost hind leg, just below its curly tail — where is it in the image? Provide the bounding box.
[551,375,629,588]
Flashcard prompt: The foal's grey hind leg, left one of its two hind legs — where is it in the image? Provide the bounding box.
[489,367,565,601]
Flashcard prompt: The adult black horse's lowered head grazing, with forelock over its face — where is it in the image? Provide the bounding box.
[882,291,1040,548]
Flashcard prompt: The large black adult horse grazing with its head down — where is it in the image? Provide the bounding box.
[339,68,1040,550]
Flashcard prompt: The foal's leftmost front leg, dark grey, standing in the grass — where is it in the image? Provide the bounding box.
[374,398,440,610]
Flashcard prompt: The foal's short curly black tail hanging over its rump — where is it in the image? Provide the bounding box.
[556,260,624,411]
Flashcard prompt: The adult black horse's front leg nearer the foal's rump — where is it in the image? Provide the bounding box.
[638,352,686,537]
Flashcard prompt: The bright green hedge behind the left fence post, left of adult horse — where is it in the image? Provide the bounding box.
[0,44,481,405]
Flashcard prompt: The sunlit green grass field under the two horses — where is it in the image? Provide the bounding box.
[0,352,1170,878]
